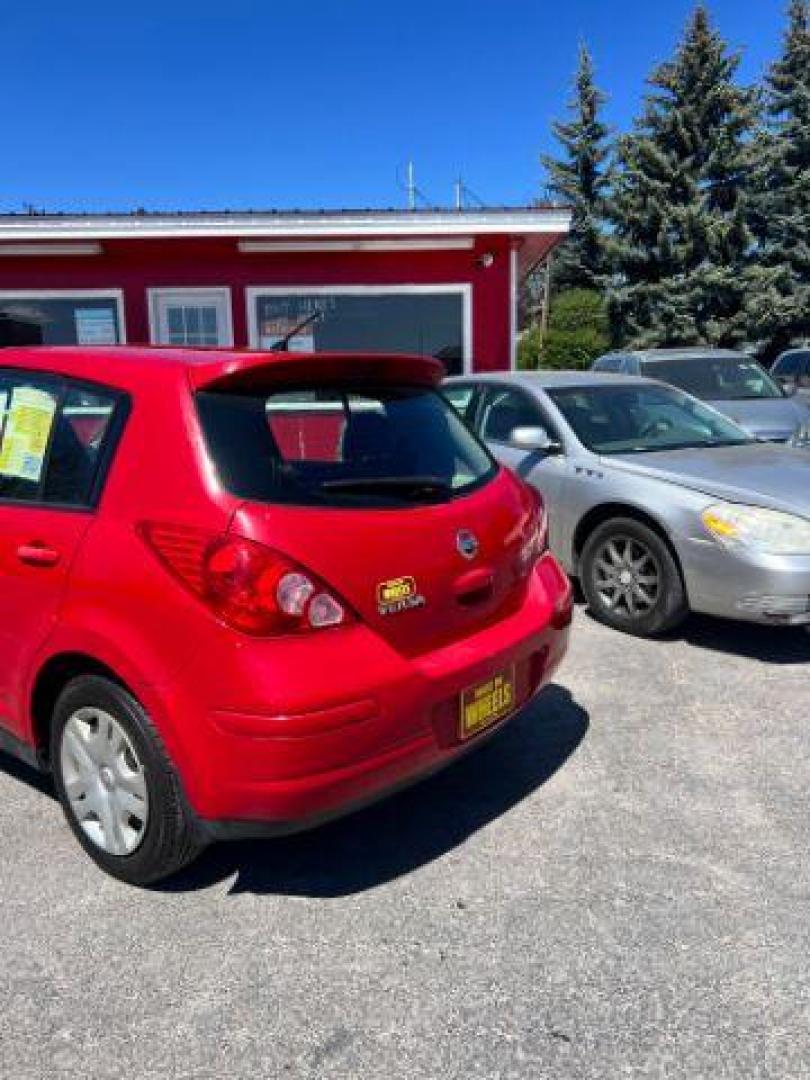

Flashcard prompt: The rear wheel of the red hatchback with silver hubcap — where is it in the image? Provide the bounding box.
[51,675,203,885]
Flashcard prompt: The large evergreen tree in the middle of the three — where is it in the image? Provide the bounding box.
[611,6,757,346]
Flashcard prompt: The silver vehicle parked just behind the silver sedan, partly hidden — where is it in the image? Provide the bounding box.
[591,348,810,446]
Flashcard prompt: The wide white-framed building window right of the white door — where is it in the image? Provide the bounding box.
[247,285,470,374]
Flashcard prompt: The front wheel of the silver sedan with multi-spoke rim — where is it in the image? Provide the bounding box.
[580,517,689,637]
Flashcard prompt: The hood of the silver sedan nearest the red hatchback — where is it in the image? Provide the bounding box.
[602,443,810,517]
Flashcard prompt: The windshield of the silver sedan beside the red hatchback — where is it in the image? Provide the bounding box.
[548,383,754,454]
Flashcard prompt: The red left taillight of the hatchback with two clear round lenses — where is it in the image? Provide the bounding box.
[139,522,351,635]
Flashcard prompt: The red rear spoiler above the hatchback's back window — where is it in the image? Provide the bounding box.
[188,352,445,393]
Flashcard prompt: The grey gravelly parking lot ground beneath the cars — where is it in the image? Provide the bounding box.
[0,610,810,1080]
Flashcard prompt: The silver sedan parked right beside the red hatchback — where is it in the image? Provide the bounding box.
[444,372,810,636]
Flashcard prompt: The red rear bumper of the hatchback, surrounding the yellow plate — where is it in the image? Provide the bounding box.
[174,556,571,825]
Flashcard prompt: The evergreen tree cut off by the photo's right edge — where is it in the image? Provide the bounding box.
[751,0,810,353]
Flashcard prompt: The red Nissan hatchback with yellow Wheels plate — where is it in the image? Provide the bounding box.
[0,348,571,883]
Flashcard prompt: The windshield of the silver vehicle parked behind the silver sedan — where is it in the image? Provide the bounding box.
[642,355,784,402]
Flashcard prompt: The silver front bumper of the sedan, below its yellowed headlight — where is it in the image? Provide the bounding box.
[683,541,810,626]
